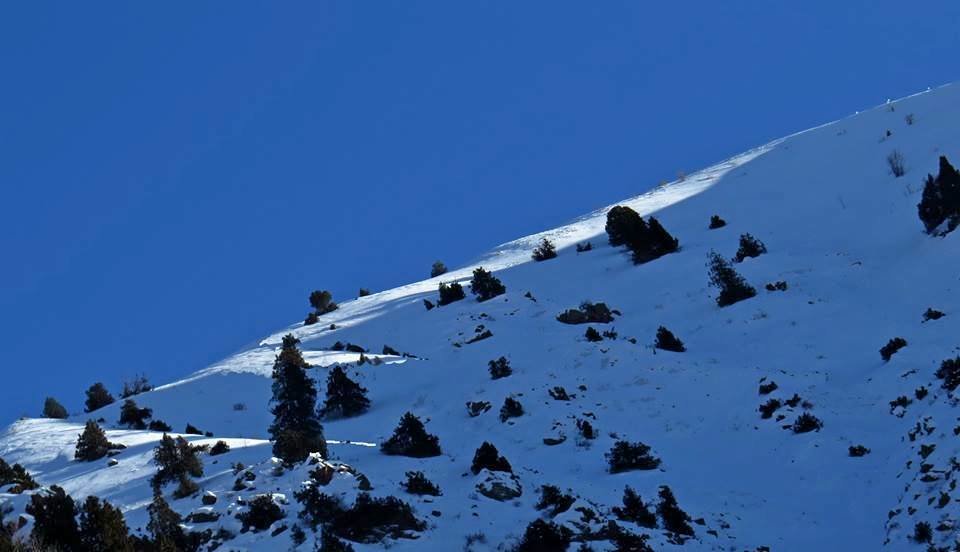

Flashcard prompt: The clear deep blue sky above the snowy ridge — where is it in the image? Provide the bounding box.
[0,0,960,422]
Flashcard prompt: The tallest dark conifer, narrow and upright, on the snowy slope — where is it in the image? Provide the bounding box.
[268,334,327,464]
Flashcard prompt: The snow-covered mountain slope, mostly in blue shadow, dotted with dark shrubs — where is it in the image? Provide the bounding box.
[0,86,960,551]
